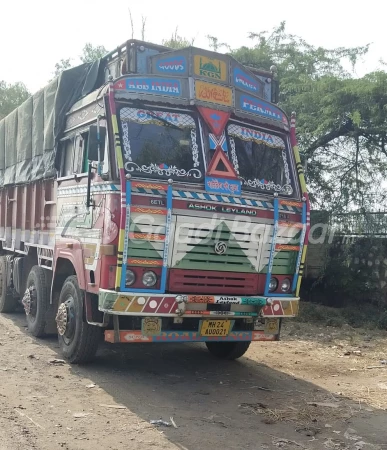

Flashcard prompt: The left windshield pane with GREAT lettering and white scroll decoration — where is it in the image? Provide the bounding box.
[120,107,204,182]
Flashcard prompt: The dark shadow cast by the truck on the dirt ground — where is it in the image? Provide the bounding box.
[8,314,387,450]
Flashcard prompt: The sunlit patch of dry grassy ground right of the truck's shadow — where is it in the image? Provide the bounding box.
[281,321,387,410]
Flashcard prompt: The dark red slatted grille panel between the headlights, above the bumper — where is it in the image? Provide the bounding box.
[168,269,260,295]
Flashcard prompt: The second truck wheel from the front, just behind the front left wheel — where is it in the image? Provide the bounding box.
[22,266,51,337]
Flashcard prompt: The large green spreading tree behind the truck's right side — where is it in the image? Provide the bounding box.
[230,22,387,211]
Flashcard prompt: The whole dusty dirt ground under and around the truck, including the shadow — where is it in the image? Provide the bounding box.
[0,314,387,450]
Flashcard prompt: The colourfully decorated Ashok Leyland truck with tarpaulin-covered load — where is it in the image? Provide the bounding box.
[0,40,309,363]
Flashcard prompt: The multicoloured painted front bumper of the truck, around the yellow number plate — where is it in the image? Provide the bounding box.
[98,289,299,343]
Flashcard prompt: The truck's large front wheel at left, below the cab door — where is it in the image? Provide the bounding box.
[56,275,101,364]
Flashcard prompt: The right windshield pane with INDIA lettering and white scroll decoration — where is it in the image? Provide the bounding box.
[227,124,294,195]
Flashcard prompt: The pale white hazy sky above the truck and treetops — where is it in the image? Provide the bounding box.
[0,0,387,92]
